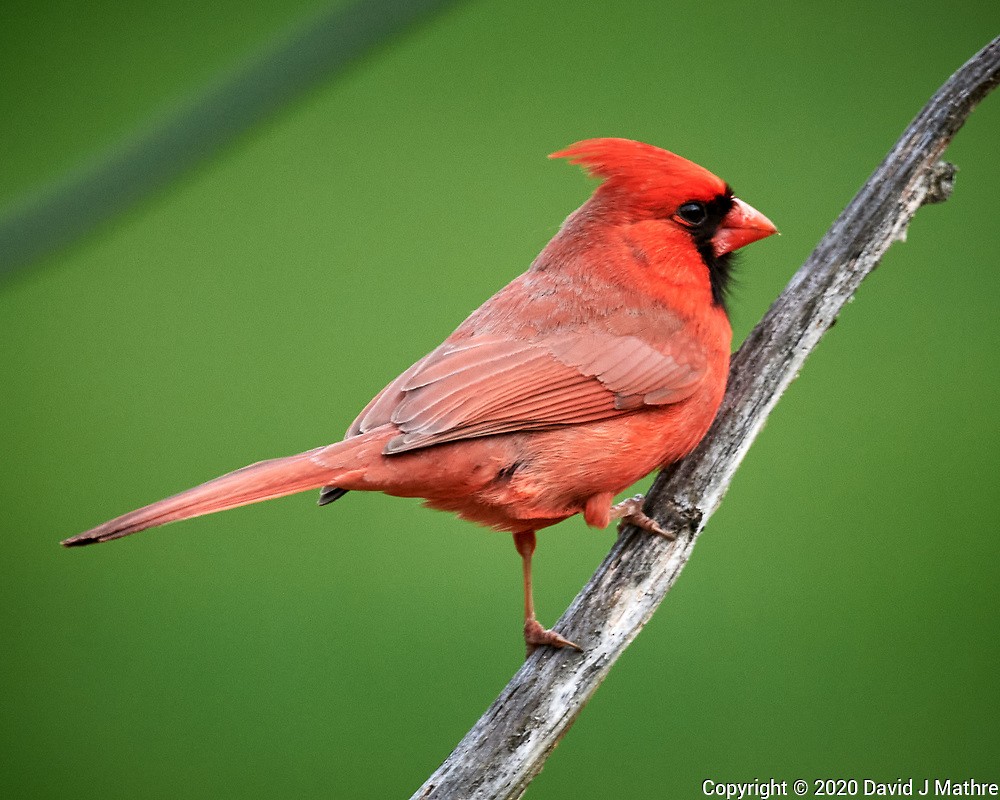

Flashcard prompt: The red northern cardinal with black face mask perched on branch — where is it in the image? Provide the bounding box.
[63,139,776,652]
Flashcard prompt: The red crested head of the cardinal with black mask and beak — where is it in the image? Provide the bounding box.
[549,139,778,305]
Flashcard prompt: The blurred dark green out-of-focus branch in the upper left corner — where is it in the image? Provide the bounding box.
[0,0,458,280]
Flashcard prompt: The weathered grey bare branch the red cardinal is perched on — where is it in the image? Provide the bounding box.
[413,37,1000,800]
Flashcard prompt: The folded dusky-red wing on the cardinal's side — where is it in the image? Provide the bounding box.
[348,329,706,454]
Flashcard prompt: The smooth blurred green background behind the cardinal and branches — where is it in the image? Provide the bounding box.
[0,0,1000,798]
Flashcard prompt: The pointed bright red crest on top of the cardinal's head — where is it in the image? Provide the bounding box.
[549,139,726,211]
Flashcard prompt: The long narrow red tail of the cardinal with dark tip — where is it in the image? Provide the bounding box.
[62,447,337,547]
